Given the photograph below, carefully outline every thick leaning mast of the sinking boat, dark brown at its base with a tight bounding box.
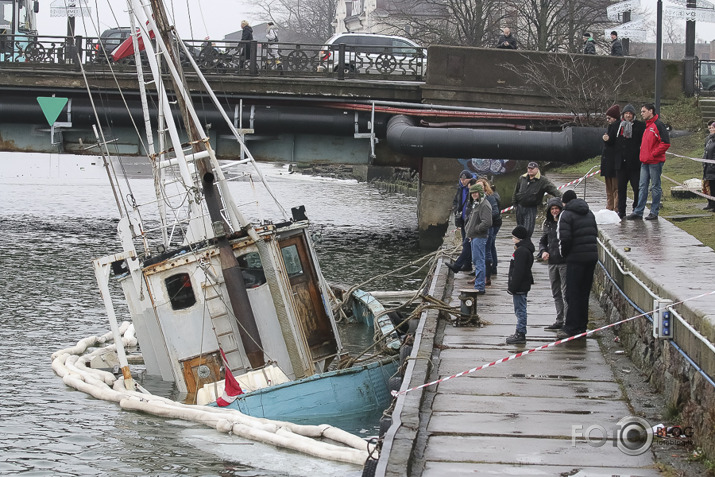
[136,0,265,368]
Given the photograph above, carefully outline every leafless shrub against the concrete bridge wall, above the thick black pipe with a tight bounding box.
[500,53,633,125]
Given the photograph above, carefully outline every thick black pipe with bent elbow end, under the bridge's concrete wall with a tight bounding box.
[387,115,603,164]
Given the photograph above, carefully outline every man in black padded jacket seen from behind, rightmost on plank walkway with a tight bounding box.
[556,190,598,339]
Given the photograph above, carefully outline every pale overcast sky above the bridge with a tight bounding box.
[38,0,715,42]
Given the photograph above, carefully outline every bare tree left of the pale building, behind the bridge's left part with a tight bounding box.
[256,0,338,43]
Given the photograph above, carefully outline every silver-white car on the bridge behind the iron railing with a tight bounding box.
[319,33,427,77]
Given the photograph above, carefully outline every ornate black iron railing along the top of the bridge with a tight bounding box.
[0,35,427,81]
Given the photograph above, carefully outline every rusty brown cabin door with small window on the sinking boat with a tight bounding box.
[279,234,337,362]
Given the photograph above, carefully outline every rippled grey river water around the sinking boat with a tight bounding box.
[0,156,423,476]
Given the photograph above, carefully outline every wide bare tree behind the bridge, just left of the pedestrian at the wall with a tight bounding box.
[378,0,504,46]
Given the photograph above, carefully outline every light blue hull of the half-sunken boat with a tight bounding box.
[224,358,398,423]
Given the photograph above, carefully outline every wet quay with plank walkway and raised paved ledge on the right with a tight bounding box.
[376,174,715,477]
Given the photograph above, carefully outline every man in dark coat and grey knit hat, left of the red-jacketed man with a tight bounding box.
[615,104,645,219]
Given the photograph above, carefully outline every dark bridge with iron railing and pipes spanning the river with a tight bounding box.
[0,37,685,245]
